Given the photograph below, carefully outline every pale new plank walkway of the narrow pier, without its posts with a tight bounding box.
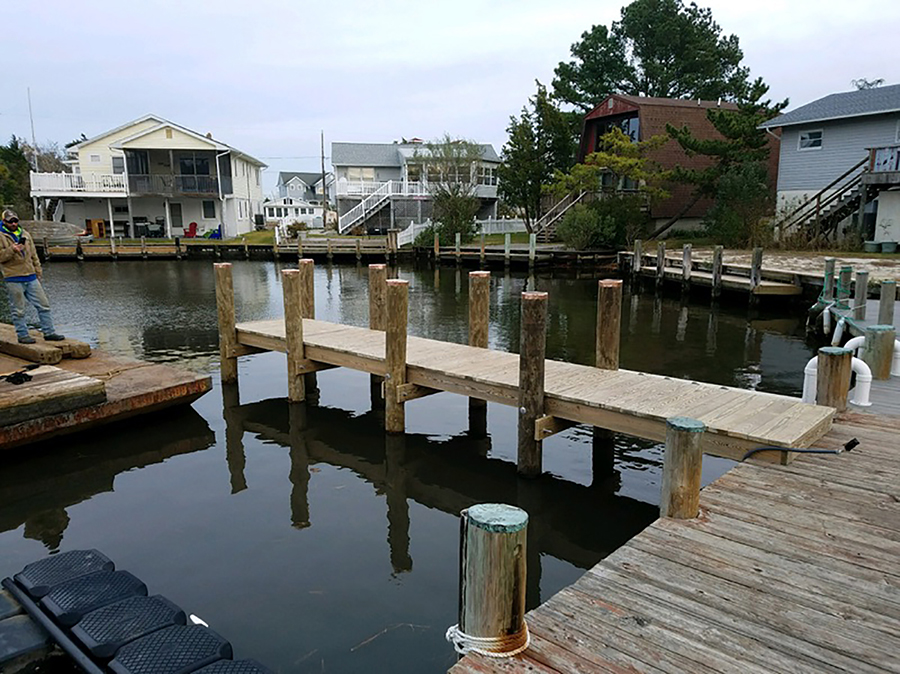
[237,319,834,459]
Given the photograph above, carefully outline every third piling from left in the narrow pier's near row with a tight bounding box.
[384,279,409,433]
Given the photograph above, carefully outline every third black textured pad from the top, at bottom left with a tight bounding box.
[72,595,187,660]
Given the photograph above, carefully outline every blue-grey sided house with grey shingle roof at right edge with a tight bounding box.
[762,85,900,241]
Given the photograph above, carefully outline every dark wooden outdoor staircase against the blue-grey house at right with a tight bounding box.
[775,156,883,239]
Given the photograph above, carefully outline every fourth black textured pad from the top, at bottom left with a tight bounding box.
[109,625,232,674]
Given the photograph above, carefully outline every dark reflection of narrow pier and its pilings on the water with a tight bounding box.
[228,399,657,588]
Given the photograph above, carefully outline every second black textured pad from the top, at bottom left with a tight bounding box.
[41,571,147,627]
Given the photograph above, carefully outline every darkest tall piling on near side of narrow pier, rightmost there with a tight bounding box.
[517,292,547,477]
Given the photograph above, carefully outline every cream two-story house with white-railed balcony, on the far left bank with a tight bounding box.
[31,115,266,238]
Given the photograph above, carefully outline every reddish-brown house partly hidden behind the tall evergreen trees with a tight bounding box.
[578,94,778,229]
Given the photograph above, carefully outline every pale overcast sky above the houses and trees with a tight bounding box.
[0,0,900,189]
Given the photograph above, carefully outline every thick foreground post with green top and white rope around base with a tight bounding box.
[458,504,533,653]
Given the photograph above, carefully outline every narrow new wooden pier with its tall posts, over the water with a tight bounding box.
[216,260,834,468]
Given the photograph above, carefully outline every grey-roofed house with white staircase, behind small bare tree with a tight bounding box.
[331,139,500,233]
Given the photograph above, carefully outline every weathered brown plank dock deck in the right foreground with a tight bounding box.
[450,413,900,674]
